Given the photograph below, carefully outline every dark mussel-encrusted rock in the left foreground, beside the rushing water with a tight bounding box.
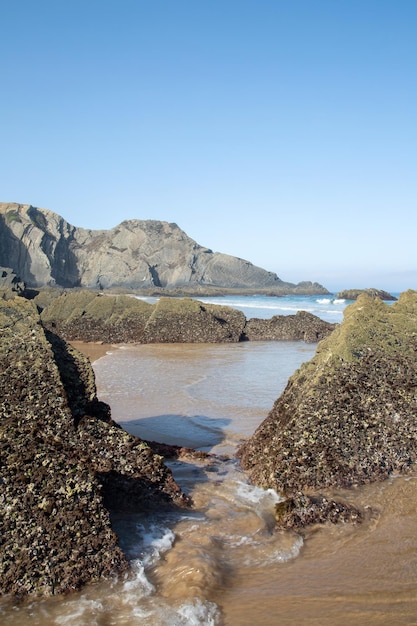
[0,298,188,594]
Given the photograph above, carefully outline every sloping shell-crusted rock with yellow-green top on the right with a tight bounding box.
[238,291,417,527]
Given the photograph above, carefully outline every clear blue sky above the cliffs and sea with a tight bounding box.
[0,0,417,291]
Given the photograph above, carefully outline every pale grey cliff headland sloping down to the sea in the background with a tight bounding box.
[0,203,327,293]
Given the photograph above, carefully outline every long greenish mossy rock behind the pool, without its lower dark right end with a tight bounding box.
[41,290,246,343]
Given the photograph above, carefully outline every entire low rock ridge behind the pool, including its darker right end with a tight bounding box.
[35,290,336,343]
